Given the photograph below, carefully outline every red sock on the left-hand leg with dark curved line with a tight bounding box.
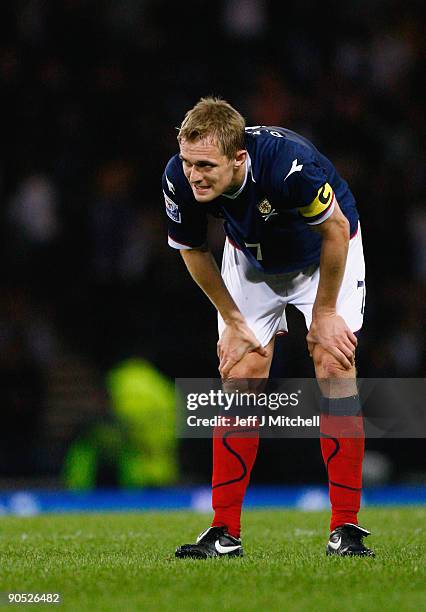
[212,427,259,538]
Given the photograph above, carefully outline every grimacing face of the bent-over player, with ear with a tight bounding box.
[180,138,247,202]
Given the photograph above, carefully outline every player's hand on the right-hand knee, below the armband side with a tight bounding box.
[306,312,358,370]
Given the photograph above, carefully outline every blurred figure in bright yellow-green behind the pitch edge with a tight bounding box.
[64,358,178,489]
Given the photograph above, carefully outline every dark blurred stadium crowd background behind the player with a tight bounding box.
[0,0,426,512]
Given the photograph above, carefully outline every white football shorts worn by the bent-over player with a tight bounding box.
[218,227,366,346]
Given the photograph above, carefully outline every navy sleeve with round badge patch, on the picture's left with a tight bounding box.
[162,158,207,250]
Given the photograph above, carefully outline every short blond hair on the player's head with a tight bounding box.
[177,97,246,159]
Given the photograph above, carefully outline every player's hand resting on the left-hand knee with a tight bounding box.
[217,323,268,379]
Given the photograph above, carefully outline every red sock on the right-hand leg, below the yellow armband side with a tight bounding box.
[320,414,364,531]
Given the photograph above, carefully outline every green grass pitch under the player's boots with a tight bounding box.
[0,507,426,612]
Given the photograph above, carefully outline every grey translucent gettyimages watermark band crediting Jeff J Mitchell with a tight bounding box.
[176,378,426,438]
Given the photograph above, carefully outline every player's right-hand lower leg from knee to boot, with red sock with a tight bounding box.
[312,344,374,556]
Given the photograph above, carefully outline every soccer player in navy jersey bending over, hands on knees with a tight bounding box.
[163,98,374,559]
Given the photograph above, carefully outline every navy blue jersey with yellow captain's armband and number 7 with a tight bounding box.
[163,126,358,274]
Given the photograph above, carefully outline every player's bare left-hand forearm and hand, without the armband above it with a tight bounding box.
[180,247,267,378]
